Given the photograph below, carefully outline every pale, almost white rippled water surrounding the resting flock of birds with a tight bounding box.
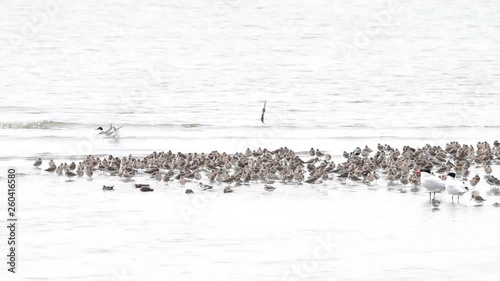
[0,0,500,281]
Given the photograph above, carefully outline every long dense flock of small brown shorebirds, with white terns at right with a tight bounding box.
[34,139,500,206]
